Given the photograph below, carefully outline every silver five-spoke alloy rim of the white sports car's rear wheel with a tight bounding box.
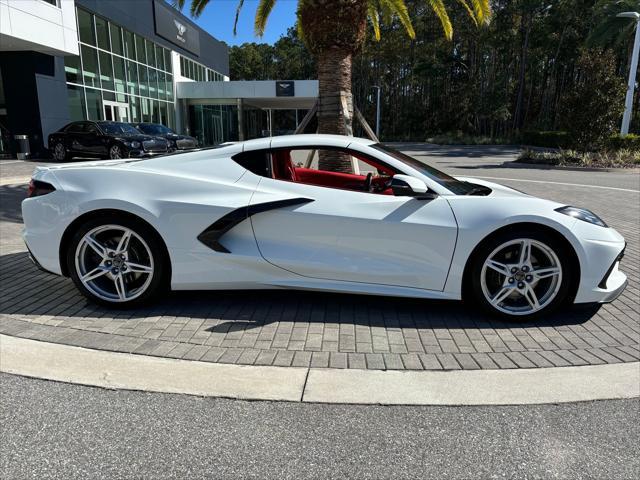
[75,225,154,302]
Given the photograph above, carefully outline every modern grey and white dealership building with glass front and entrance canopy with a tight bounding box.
[0,0,317,155]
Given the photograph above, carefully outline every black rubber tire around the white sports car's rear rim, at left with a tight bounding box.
[65,214,170,308]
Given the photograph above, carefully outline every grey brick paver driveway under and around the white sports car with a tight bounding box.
[0,151,640,369]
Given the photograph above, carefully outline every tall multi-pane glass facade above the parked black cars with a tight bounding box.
[65,8,175,128]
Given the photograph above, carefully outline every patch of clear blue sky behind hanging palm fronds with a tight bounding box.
[171,0,297,45]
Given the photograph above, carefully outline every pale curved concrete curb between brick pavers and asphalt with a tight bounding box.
[0,335,640,405]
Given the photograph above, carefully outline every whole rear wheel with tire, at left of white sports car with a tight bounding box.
[67,217,167,308]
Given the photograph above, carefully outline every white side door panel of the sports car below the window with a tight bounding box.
[251,178,457,290]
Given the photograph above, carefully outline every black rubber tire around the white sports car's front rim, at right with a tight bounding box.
[464,229,578,322]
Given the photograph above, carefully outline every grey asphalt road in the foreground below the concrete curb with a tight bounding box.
[0,375,640,479]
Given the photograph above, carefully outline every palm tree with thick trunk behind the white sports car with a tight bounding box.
[175,0,491,171]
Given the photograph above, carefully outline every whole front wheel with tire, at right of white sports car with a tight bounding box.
[470,231,575,320]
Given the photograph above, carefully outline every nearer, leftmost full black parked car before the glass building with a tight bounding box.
[49,121,169,161]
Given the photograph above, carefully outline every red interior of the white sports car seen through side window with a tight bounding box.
[272,150,394,195]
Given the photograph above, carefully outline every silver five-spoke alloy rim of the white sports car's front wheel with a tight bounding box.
[480,238,562,315]
